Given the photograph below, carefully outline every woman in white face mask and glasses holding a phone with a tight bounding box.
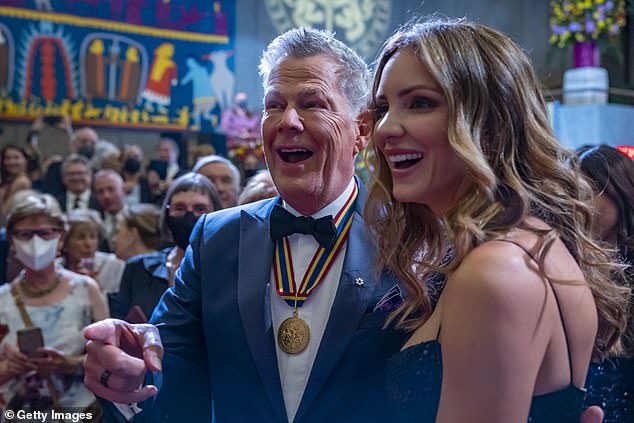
[0,192,108,413]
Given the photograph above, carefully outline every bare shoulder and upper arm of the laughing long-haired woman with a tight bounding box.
[436,243,552,423]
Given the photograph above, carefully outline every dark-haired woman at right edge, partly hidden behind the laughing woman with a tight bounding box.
[578,145,634,423]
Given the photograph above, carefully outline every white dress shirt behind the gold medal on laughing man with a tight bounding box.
[270,179,355,422]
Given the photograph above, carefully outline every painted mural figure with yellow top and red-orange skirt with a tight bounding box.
[141,43,178,113]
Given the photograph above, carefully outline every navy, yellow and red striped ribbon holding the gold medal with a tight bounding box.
[273,183,359,307]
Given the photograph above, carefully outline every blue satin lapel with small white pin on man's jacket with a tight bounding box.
[294,200,377,422]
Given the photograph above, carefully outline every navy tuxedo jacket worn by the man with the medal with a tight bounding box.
[113,190,405,423]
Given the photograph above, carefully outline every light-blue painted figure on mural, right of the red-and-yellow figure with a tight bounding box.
[181,56,216,130]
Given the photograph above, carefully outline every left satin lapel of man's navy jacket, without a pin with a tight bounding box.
[238,207,287,422]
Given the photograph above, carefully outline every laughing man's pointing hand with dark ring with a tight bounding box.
[84,319,163,404]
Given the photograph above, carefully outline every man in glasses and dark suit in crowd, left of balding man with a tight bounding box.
[56,154,101,212]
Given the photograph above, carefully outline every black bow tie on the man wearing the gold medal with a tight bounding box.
[271,204,337,250]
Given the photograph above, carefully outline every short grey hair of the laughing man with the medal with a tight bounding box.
[259,28,371,115]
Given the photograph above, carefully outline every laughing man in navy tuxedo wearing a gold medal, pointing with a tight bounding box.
[86,29,404,423]
